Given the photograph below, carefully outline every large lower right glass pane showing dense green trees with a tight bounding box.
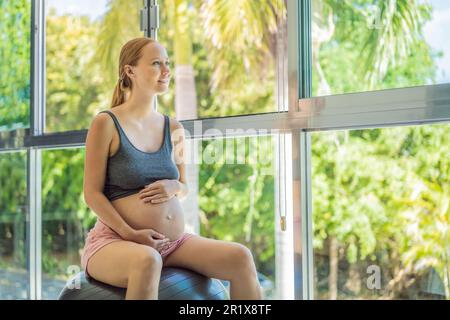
[312,124,450,299]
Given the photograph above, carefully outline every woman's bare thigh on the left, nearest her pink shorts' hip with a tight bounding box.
[87,241,159,288]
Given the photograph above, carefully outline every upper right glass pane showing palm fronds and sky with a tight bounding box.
[312,0,450,96]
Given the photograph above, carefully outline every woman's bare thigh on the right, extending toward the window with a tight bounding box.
[164,236,254,280]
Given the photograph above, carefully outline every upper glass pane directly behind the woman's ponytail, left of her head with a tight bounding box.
[46,0,143,132]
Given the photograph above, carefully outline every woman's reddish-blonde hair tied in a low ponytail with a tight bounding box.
[111,37,155,108]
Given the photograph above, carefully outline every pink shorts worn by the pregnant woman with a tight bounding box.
[81,219,194,276]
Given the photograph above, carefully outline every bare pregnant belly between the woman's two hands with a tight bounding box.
[112,193,184,240]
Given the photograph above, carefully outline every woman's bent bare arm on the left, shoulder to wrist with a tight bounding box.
[83,113,135,240]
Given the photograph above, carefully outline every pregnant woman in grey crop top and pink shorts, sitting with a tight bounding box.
[81,38,261,299]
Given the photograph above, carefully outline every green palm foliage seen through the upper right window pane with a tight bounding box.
[313,0,439,95]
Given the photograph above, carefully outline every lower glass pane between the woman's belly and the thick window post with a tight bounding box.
[191,136,284,299]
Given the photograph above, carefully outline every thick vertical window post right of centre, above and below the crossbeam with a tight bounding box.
[287,0,312,299]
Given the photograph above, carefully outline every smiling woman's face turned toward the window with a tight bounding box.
[127,42,171,94]
